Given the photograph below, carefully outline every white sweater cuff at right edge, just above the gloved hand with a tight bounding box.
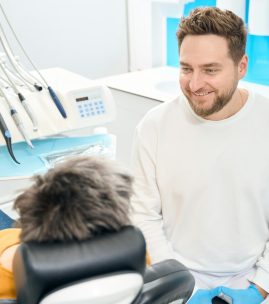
[252,242,269,293]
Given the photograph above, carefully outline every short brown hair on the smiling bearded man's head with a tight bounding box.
[177,7,247,63]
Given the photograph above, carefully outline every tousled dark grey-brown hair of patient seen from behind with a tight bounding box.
[14,157,133,242]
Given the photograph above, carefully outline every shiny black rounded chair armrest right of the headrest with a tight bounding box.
[135,260,194,304]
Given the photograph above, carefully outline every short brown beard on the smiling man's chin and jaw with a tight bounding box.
[184,83,237,118]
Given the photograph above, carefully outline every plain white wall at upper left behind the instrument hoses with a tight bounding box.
[0,0,128,79]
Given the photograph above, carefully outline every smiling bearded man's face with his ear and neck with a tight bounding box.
[180,35,247,120]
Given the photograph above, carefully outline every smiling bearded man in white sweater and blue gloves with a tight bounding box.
[132,8,269,304]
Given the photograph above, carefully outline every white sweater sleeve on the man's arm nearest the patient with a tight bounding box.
[132,121,174,263]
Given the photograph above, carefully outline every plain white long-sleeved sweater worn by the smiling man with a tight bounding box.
[132,93,269,292]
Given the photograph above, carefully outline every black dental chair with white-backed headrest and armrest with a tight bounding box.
[9,226,194,304]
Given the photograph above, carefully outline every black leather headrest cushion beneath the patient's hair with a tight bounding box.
[13,226,146,304]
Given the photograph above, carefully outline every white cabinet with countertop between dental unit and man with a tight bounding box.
[99,67,179,167]
